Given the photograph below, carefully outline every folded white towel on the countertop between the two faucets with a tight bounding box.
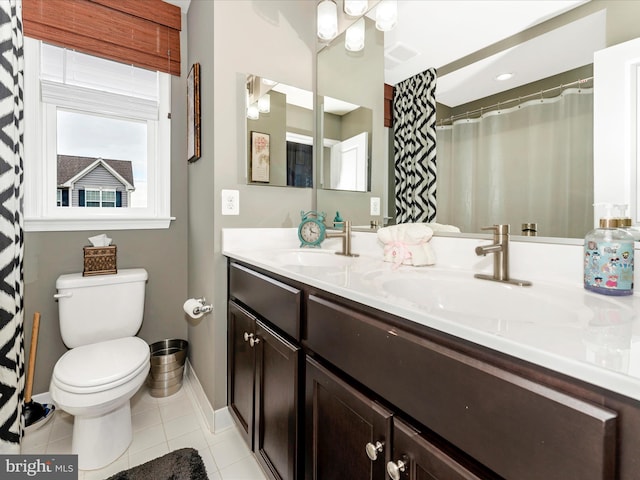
[378,223,436,266]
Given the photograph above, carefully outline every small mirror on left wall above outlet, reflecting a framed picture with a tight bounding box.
[245,74,314,188]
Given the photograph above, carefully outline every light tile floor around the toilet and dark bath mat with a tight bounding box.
[22,382,266,480]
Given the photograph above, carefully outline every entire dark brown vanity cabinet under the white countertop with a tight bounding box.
[228,262,640,480]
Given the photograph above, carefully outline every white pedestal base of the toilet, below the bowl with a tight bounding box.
[71,400,133,470]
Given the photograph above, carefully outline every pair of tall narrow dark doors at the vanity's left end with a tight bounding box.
[227,262,301,480]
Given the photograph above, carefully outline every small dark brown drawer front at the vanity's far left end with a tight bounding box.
[229,263,302,340]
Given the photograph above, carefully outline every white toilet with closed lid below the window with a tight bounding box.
[49,268,150,470]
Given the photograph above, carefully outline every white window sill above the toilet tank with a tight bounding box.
[24,217,175,232]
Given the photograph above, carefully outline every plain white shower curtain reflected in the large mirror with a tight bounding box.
[437,88,593,238]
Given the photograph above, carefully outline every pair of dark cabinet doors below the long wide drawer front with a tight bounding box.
[305,357,484,480]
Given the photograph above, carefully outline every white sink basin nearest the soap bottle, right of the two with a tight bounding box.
[378,270,633,330]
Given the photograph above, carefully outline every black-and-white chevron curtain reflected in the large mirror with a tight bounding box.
[393,68,436,223]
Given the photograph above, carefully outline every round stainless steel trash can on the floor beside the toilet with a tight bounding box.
[147,339,189,397]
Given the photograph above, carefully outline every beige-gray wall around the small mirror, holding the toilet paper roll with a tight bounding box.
[187,0,316,409]
